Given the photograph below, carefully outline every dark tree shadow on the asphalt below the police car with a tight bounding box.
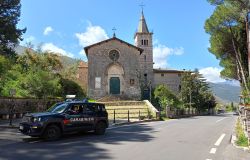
[0,124,154,160]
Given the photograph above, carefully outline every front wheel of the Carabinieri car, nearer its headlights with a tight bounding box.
[43,125,62,141]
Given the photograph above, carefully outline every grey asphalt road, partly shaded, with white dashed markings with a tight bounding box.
[0,114,250,160]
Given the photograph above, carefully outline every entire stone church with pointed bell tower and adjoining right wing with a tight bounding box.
[79,12,181,100]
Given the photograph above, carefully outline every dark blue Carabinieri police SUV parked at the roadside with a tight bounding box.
[19,101,109,140]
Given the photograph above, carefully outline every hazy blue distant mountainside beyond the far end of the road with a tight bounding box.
[209,83,241,103]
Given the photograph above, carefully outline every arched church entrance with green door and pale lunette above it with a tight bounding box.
[107,64,124,95]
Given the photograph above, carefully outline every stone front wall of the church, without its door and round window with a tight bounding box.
[88,39,141,99]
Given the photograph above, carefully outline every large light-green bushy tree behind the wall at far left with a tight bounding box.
[0,49,62,98]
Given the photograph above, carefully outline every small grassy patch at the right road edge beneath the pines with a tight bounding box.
[236,119,249,147]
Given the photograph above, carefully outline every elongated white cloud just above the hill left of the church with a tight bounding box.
[41,43,74,58]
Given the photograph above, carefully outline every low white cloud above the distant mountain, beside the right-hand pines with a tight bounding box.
[199,67,226,83]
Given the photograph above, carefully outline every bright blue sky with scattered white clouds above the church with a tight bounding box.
[18,0,236,83]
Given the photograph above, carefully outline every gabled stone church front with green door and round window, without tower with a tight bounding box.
[85,36,143,99]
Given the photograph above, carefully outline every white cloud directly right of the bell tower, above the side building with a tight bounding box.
[153,42,184,68]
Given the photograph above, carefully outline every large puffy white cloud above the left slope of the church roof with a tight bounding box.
[75,22,108,55]
